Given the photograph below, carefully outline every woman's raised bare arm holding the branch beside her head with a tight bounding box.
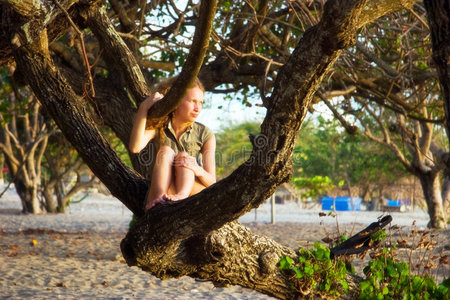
[128,93,163,153]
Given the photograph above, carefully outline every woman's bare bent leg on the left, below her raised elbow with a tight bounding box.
[145,146,175,210]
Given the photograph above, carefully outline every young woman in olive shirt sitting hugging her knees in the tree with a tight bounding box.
[129,78,216,210]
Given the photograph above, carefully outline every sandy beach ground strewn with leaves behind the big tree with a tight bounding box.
[0,188,450,299]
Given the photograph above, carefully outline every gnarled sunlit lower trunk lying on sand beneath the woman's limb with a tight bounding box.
[121,216,358,299]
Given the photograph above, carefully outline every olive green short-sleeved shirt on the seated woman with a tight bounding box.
[147,122,213,179]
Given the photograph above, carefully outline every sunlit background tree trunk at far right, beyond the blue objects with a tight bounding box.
[417,171,447,228]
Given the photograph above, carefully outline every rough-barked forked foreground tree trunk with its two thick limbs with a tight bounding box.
[0,0,414,298]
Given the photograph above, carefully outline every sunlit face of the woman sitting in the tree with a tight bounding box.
[173,87,204,122]
